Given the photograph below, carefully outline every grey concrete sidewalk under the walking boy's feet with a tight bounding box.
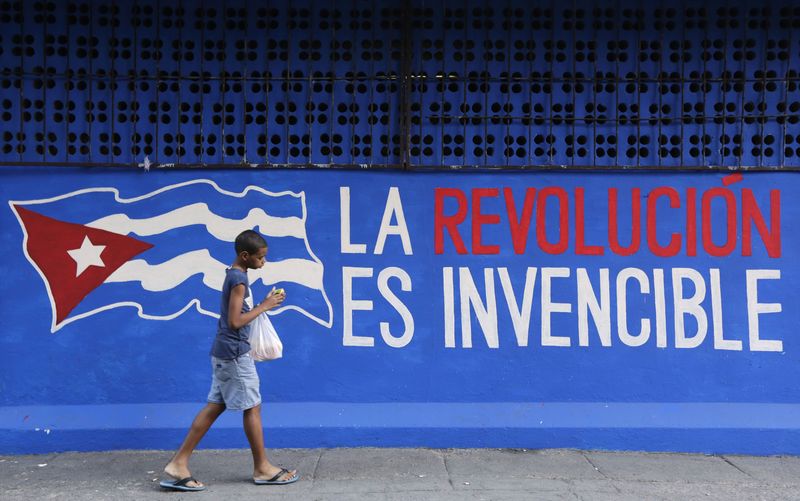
[0,448,800,501]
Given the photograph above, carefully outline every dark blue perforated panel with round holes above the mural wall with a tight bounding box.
[0,0,800,169]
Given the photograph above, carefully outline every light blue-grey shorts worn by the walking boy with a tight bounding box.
[208,353,261,411]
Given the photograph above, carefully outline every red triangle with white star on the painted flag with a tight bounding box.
[14,205,153,325]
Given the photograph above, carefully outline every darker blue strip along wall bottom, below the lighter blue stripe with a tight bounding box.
[0,428,800,455]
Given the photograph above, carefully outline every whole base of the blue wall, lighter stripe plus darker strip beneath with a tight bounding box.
[0,402,800,455]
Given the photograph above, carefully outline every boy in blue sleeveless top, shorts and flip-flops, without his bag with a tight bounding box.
[160,230,300,491]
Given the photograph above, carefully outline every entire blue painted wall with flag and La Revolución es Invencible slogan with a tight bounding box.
[0,168,800,454]
